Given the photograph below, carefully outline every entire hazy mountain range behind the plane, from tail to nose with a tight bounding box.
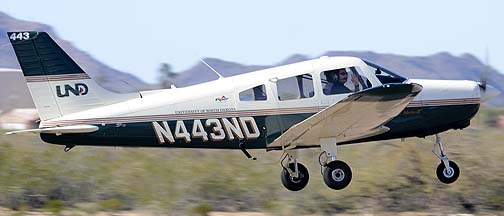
[0,12,504,111]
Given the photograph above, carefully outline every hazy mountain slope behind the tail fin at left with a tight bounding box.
[0,12,150,93]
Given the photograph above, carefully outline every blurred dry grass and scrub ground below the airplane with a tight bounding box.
[0,106,504,215]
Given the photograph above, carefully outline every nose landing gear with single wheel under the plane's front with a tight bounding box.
[432,134,460,184]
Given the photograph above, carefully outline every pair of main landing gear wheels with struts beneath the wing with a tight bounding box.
[280,138,352,191]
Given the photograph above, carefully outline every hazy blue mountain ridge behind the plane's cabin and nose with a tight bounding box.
[175,51,504,106]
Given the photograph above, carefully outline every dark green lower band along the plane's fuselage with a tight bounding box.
[41,104,479,149]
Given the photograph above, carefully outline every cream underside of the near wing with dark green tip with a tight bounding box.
[268,83,422,148]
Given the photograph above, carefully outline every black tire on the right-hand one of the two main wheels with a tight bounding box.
[323,160,352,190]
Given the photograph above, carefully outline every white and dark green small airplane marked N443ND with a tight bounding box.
[7,31,499,191]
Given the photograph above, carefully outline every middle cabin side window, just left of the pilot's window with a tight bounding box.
[277,74,314,101]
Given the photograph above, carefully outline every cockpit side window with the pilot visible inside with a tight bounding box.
[320,67,371,95]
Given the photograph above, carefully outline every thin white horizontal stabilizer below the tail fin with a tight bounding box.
[5,125,99,135]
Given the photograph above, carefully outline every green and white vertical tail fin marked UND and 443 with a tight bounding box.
[7,32,131,121]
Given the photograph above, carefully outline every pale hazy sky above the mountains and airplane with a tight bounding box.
[0,0,504,82]
